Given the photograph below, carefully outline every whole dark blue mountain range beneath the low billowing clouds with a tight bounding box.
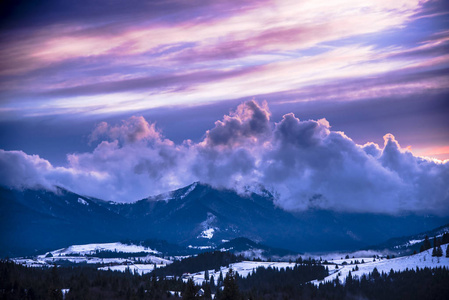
[0,183,449,256]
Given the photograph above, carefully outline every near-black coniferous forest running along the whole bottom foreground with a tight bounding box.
[0,261,449,300]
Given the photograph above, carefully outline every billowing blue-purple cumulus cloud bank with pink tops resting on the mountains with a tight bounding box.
[0,101,449,215]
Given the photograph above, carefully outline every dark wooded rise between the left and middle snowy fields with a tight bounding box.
[155,251,244,276]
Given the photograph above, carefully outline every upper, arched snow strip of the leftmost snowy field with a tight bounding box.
[40,242,159,257]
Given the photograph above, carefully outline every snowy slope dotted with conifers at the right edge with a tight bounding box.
[312,244,449,285]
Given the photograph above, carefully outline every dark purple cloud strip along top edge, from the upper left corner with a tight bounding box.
[0,0,266,27]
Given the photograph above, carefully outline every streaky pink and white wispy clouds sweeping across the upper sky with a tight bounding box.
[0,0,449,116]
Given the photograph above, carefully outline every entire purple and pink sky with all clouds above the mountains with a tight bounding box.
[0,0,449,214]
